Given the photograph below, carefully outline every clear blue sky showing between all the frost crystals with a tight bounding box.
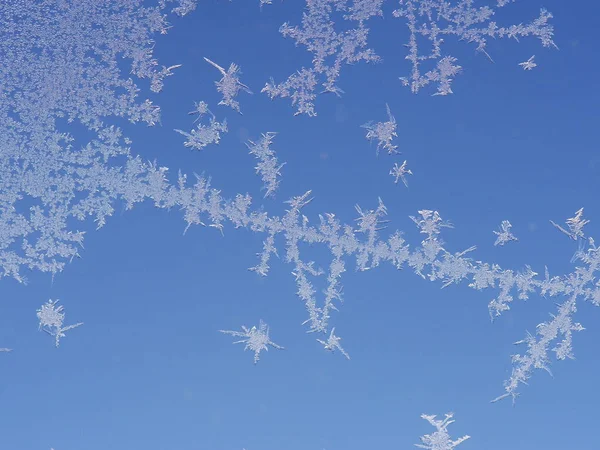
[0,0,600,450]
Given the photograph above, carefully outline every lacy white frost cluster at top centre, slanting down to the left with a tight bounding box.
[262,0,383,116]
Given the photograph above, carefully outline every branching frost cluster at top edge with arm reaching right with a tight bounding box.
[393,0,556,95]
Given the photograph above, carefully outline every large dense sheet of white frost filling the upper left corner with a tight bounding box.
[0,0,195,281]
